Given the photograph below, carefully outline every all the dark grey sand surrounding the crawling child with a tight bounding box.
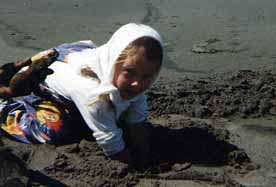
[0,0,276,187]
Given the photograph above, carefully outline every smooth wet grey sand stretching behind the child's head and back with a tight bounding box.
[0,0,276,76]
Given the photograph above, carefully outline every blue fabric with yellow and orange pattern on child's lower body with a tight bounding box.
[1,95,65,143]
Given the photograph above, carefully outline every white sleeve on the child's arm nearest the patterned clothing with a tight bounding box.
[70,92,125,156]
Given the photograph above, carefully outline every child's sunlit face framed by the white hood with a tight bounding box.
[113,47,160,100]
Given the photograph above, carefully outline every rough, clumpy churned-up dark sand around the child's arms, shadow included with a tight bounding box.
[0,71,276,187]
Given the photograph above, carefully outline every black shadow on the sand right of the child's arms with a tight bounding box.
[149,124,250,166]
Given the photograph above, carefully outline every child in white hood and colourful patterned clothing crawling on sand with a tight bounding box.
[2,23,163,166]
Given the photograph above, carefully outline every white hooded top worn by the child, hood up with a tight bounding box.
[46,23,163,155]
